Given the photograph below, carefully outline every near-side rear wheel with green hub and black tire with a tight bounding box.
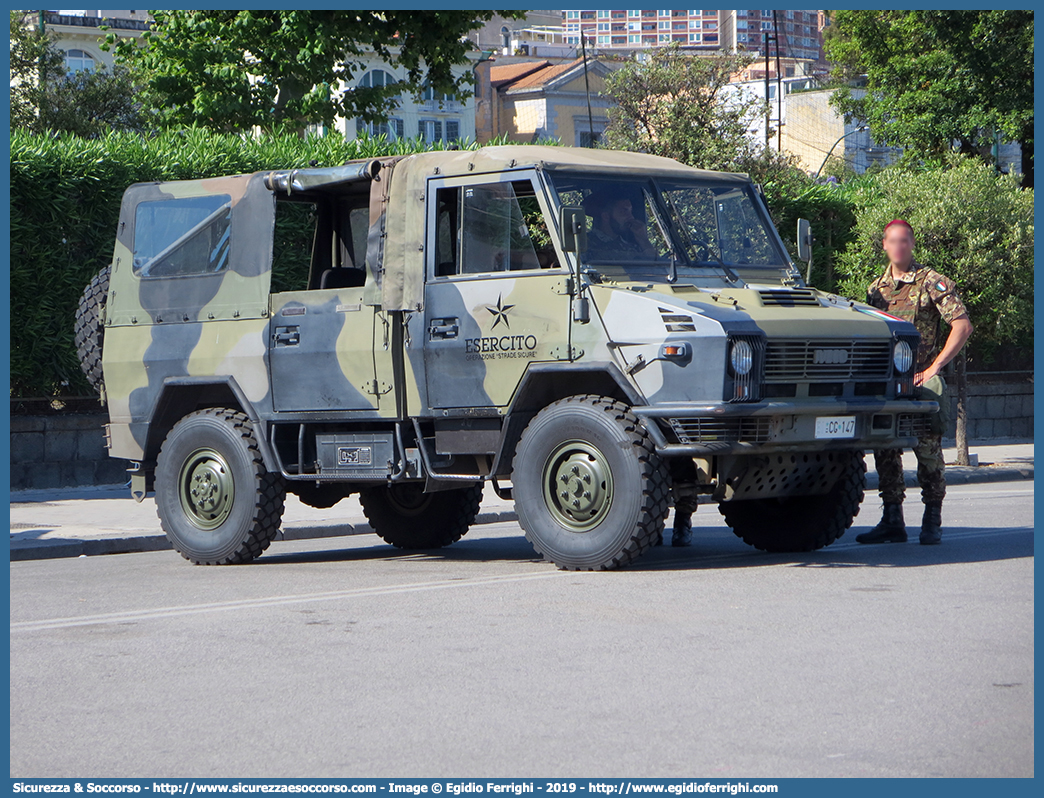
[156,407,286,565]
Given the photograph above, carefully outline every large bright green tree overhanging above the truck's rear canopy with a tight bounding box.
[105,10,523,132]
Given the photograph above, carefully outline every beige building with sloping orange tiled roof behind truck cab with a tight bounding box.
[476,58,614,146]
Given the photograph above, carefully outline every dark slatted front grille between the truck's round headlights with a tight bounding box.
[765,339,892,382]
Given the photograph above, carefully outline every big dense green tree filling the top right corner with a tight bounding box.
[824,10,1034,187]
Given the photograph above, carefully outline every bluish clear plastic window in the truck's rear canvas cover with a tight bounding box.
[134,194,232,277]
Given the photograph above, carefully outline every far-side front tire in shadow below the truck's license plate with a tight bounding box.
[718,451,867,553]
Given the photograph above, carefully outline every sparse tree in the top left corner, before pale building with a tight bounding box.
[10,11,65,131]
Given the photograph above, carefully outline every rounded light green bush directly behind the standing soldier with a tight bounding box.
[838,154,1034,361]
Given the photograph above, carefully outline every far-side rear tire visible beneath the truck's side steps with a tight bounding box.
[359,483,482,548]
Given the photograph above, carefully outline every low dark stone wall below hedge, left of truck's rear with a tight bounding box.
[10,414,128,491]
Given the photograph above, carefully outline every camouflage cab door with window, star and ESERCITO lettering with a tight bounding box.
[424,170,570,408]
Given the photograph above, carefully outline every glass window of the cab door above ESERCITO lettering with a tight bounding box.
[435,181,557,277]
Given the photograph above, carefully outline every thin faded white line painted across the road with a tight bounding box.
[10,569,576,633]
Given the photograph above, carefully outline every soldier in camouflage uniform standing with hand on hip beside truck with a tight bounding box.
[856,219,972,544]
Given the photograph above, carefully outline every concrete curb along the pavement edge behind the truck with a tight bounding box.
[10,464,1034,562]
